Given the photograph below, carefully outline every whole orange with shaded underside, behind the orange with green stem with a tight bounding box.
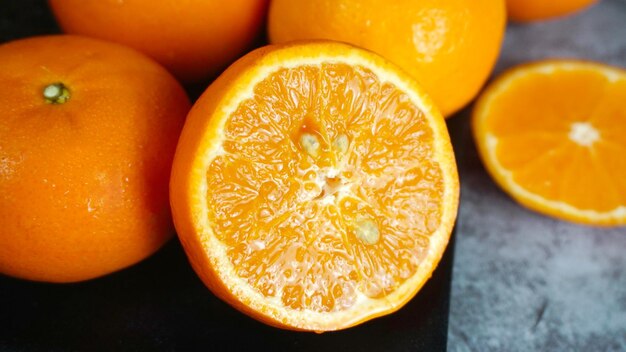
[49,0,268,83]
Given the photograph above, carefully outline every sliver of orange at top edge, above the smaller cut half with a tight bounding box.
[506,0,598,22]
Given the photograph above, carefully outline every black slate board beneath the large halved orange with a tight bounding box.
[0,0,453,351]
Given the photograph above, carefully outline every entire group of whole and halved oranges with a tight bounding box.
[0,0,626,332]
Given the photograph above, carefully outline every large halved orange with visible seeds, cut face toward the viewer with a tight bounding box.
[170,42,459,331]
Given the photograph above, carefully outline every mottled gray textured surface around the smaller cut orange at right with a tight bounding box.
[448,0,626,352]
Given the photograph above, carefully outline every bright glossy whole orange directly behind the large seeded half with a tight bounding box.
[268,0,506,116]
